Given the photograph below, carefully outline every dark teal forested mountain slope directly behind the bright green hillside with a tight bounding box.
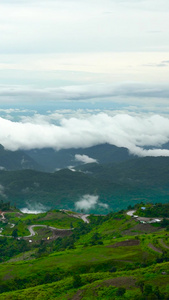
[0,157,169,214]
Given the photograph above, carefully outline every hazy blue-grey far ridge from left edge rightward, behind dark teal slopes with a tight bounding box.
[0,143,169,172]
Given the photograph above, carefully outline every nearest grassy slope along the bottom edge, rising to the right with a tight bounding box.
[0,263,169,300]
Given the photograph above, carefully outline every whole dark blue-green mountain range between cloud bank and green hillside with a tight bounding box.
[0,144,169,214]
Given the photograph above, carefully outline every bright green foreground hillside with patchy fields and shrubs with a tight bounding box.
[0,204,169,300]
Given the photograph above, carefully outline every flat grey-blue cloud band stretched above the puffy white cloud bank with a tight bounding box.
[0,82,169,105]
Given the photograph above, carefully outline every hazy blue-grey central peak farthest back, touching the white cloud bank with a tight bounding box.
[25,144,134,172]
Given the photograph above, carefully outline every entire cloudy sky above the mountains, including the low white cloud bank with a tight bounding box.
[0,0,169,156]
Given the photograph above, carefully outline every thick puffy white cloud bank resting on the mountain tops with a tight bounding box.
[0,113,169,157]
